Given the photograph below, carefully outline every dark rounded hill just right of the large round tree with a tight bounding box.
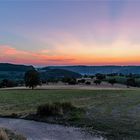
[40,68,81,79]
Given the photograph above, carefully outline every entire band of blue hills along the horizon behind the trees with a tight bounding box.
[0,63,140,80]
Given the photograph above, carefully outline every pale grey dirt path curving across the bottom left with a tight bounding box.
[0,118,103,140]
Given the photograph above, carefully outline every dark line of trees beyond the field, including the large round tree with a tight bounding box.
[0,69,140,89]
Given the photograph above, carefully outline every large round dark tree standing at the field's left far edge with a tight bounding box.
[24,70,40,89]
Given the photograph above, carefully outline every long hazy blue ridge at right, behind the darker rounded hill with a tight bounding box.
[43,66,140,75]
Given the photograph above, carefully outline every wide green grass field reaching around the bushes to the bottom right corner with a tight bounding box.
[0,90,140,139]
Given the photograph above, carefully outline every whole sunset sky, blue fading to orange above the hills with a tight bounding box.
[0,0,140,66]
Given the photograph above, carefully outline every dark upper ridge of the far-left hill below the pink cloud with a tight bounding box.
[0,63,34,72]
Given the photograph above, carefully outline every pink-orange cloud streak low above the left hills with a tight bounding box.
[0,45,74,65]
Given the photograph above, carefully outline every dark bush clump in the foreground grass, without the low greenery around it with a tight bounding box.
[37,102,75,116]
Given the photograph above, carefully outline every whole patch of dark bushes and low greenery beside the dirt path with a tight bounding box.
[35,102,85,125]
